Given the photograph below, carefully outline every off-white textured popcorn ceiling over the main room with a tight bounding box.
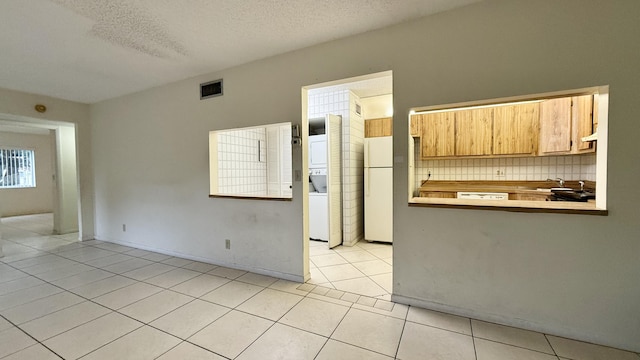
[0,0,479,103]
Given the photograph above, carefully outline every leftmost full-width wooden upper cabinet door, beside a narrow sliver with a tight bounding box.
[420,111,455,158]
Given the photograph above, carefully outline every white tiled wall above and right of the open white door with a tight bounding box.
[308,89,364,243]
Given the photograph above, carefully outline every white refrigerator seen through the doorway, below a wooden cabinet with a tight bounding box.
[364,136,393,242]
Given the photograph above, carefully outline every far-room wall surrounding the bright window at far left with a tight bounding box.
[0,132,53,216]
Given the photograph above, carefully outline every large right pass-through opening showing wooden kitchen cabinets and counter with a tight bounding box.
[408,86,609,215]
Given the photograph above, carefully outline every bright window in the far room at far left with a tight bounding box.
[0,148,36,189]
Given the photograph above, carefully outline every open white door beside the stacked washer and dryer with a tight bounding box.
[325,115,342,248]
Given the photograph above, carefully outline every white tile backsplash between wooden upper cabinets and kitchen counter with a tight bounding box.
[414,139,596,187]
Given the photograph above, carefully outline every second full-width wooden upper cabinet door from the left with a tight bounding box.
[455,108,493,156]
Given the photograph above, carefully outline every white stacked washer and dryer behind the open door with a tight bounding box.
[309,135,329,241]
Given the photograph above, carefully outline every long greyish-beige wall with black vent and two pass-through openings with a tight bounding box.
[89,0,640,351]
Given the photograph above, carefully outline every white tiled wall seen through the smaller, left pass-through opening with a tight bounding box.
[218,128,267,196]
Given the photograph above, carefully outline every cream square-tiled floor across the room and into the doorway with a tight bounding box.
[0,215,640,360]
